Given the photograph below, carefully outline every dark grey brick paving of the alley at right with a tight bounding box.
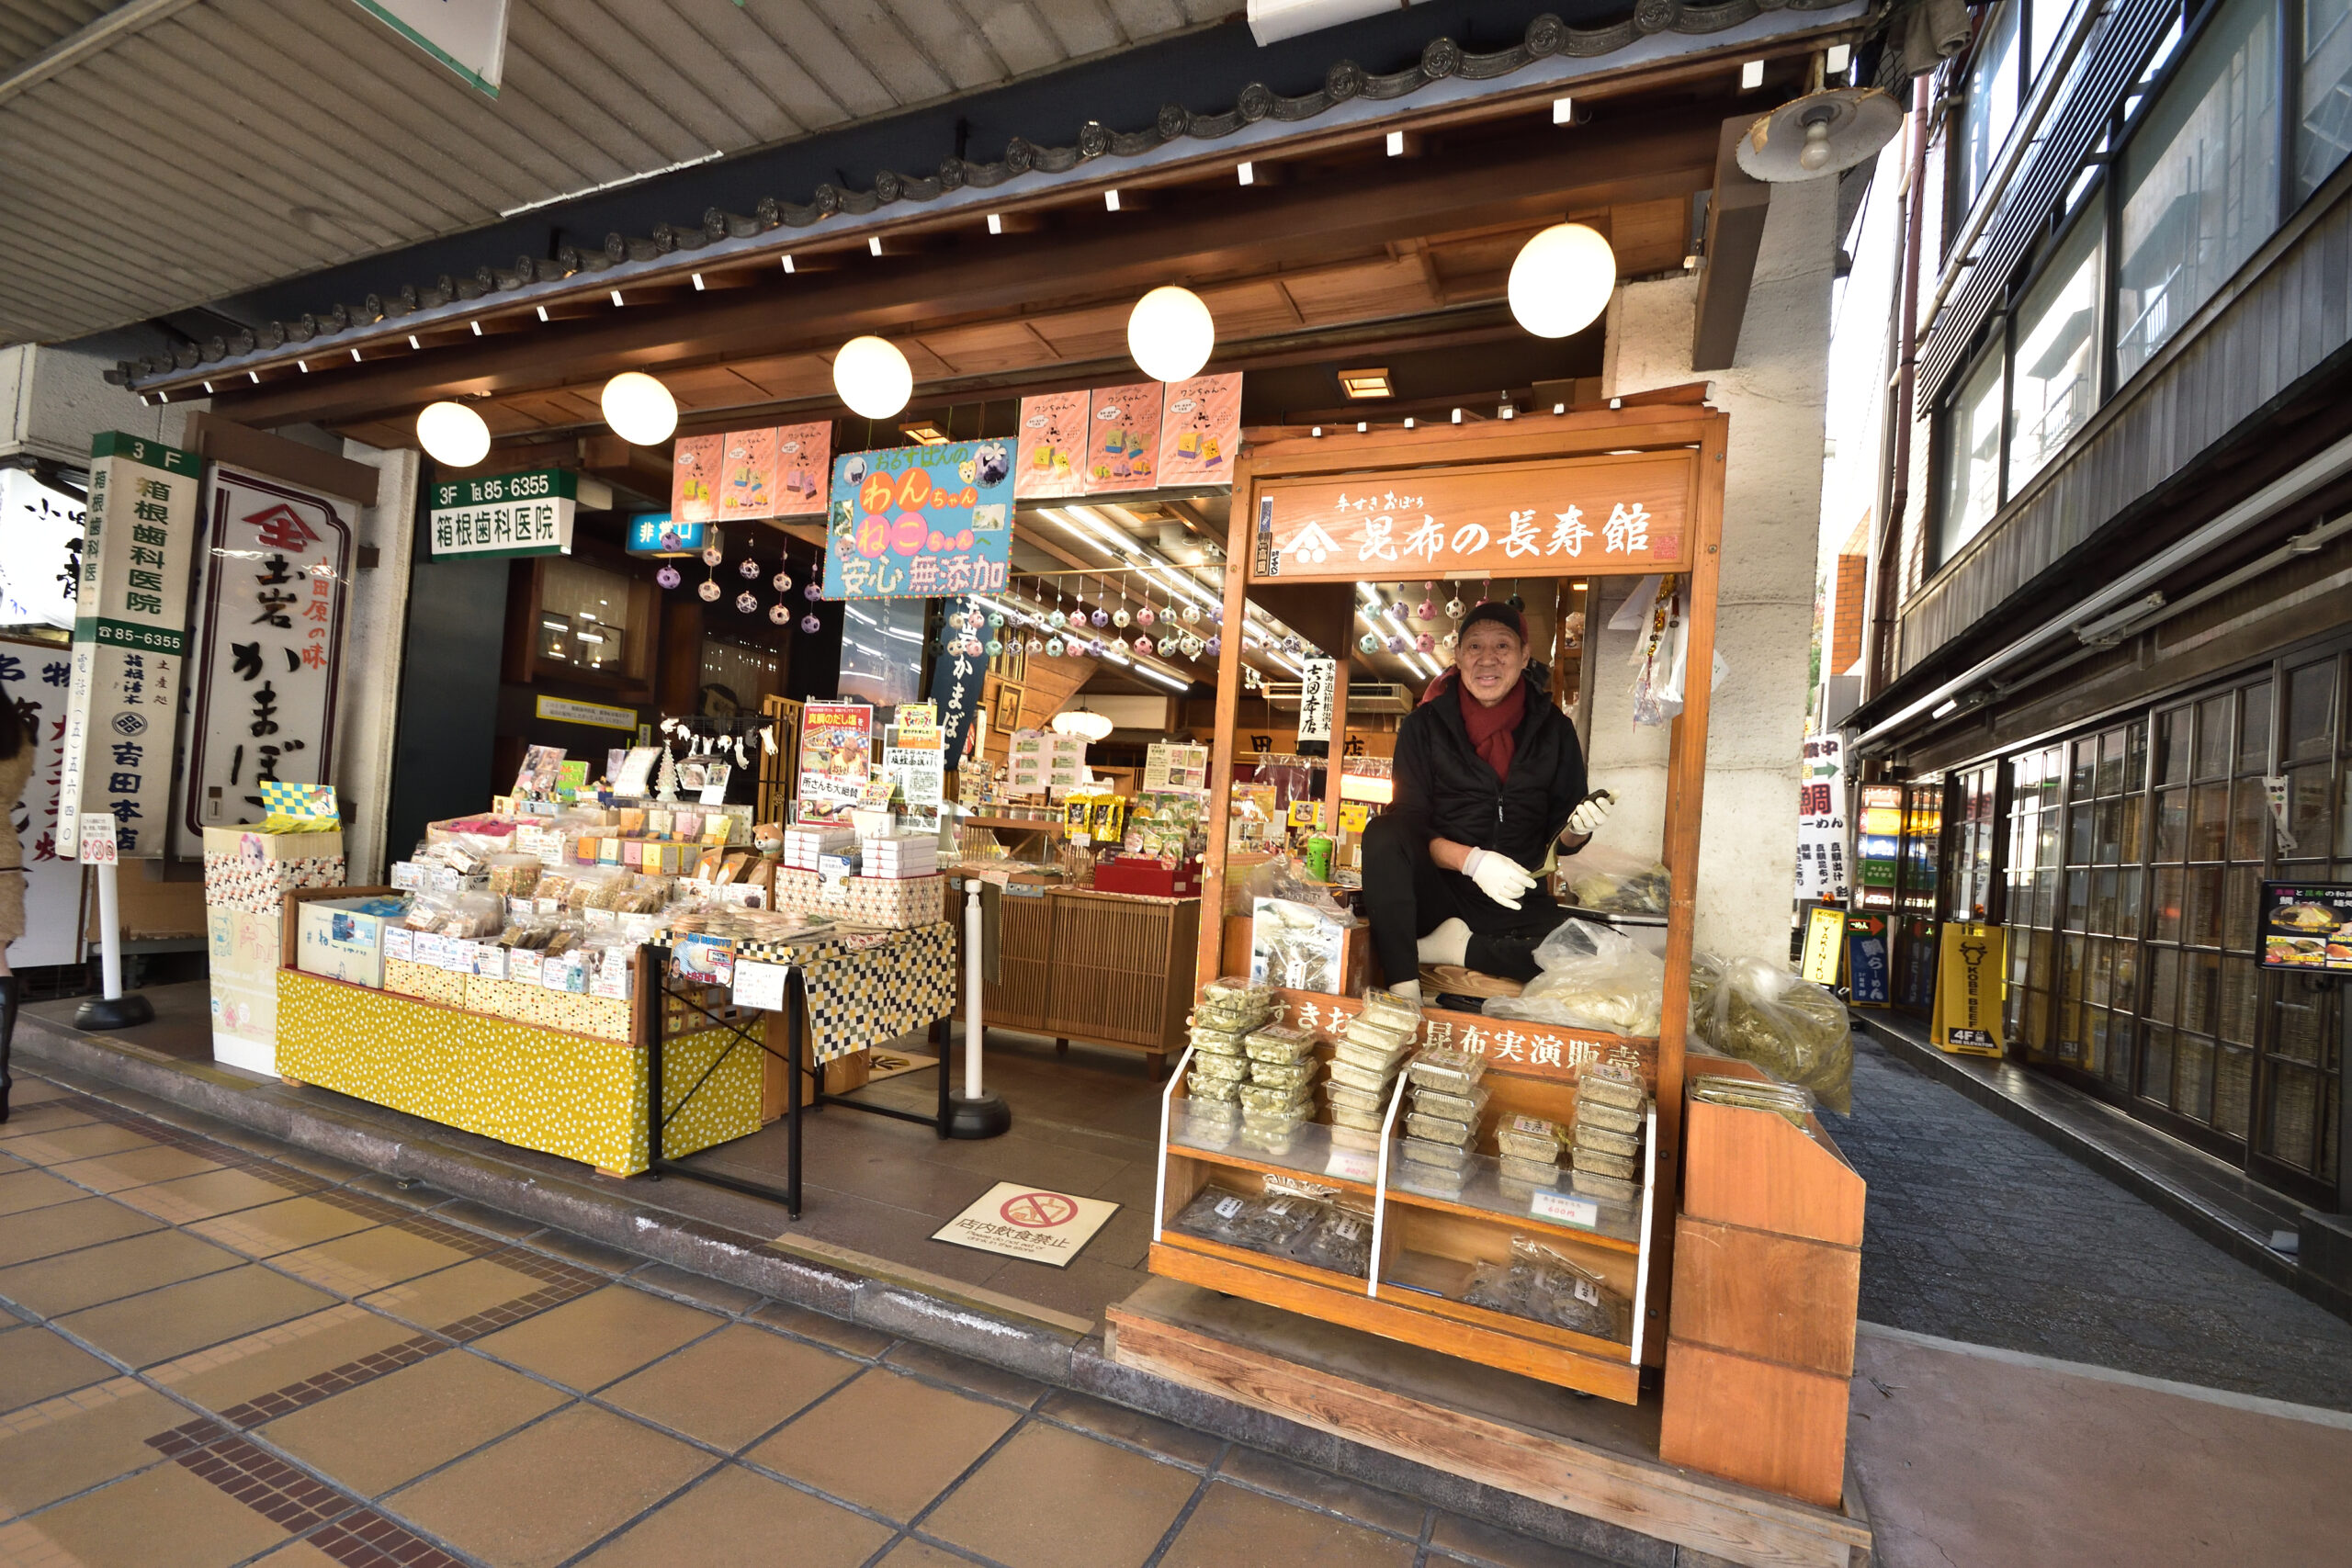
[1823,1032,2352,1411]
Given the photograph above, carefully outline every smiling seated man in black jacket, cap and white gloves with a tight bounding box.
[1364,602,1613,997]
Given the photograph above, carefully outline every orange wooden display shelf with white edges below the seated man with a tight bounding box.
[1150,1043,1656,1404]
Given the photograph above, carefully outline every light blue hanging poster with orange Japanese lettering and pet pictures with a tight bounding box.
[826,440,1013,600]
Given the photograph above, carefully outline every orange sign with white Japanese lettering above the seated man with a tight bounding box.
[1249,451,1693,583]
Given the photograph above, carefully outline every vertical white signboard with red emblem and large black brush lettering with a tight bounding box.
[181,463,350,840]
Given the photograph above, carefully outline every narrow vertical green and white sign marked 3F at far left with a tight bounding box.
[56,430,202,861]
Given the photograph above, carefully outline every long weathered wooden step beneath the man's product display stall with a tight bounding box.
[1108,1279,1870,1568]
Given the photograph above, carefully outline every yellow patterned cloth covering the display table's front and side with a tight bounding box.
[277,971,760,1176]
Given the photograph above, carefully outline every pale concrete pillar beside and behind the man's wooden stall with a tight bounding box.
[1585,179,1837,959]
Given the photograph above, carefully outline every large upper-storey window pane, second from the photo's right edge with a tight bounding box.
[2114,0,2279,381]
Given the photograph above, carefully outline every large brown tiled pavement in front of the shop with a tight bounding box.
[0,1077,1583,1568]
